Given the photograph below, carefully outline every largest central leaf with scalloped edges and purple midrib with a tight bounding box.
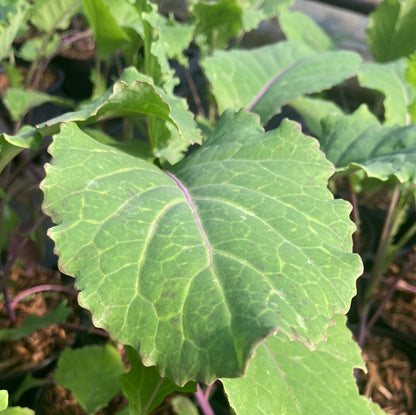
[42,110,361,385]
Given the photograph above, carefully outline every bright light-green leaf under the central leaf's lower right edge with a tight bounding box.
[222,315,384,415]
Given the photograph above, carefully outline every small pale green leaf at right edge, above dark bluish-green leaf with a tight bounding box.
[358,59,415,125]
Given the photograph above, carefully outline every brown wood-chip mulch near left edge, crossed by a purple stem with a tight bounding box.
[0,269,77,374]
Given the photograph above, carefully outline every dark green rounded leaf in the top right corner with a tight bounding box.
[367,0,416,62]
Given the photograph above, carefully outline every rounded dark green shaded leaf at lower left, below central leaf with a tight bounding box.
[55,343,126,414]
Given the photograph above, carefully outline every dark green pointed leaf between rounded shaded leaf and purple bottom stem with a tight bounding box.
[120,346,196,415]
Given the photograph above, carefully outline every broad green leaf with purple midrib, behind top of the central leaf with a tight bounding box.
[203,42,361,123]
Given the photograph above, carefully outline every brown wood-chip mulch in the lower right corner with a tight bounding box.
[359,248,416,415]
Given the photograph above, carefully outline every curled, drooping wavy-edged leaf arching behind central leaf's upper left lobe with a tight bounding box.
[0,68,202,167]
